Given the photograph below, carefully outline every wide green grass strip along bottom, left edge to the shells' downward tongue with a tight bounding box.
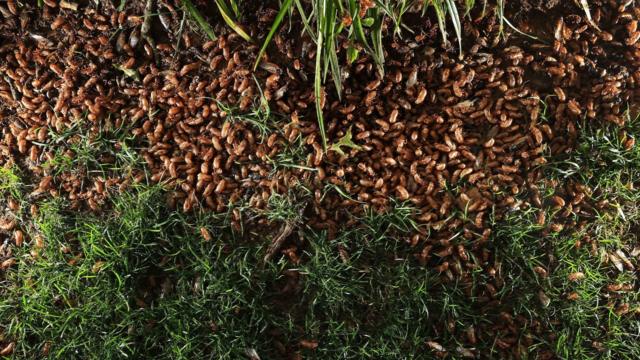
[0,186,472,359]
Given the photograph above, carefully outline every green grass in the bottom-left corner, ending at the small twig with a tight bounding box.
[0,187,282,359]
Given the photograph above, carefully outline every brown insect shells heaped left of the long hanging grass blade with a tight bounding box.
[0,2,298,224]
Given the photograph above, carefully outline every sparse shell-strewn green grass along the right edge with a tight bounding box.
[494,111,640,359]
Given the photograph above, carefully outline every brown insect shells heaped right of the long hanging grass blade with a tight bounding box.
[258,0,640,270]
